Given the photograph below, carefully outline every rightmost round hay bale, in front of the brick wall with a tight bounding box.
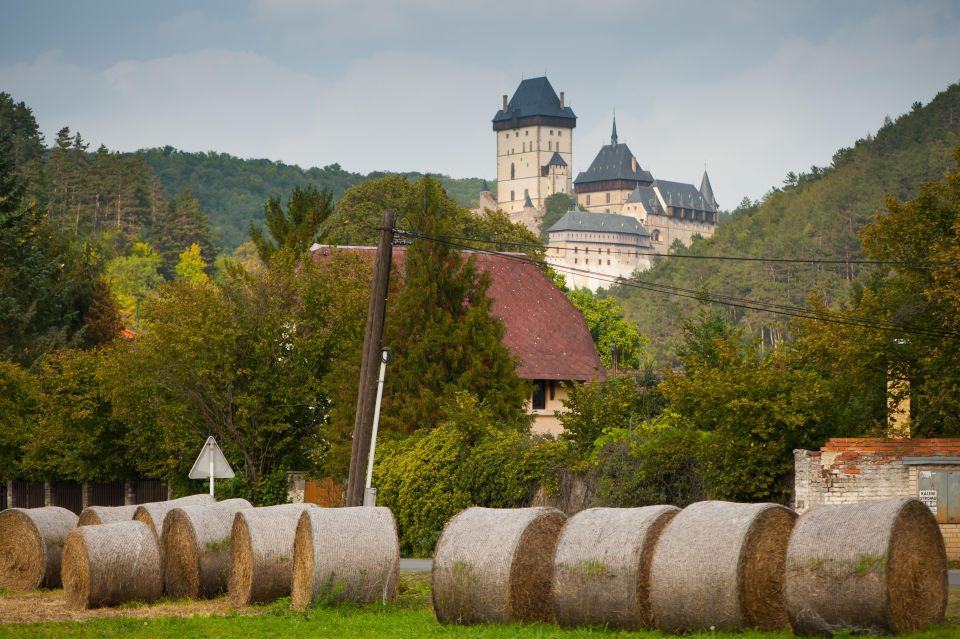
[786,498,949,635]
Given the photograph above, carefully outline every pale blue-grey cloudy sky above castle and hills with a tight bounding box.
[0,0,960,209]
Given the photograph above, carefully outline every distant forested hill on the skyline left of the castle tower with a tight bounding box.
[137,146,483,251]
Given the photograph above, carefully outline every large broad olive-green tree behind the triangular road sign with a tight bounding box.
[107,251,364,494]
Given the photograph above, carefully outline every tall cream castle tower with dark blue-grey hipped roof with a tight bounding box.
[493,77,577,219]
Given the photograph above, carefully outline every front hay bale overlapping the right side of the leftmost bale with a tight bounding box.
[61,520,163,608]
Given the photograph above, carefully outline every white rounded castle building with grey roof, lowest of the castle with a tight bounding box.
[546,211,653,292]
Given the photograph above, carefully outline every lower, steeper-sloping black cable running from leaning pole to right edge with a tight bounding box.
[398,231,960,339]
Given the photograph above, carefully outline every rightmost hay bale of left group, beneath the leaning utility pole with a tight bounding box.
[291,507,400,610]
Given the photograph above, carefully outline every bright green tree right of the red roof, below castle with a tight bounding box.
[567,288,652,370]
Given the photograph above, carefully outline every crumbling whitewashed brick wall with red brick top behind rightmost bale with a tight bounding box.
[794,438,960,559]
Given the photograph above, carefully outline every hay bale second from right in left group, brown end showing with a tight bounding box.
[229,504,316,607]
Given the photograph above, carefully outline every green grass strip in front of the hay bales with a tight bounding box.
[0,575,960,639]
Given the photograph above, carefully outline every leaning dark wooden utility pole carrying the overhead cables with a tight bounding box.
[346,209,393,506]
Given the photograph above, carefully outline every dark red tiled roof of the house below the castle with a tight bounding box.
[314,246,606,381]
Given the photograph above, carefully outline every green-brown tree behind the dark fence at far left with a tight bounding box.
[21,350,134,481]
